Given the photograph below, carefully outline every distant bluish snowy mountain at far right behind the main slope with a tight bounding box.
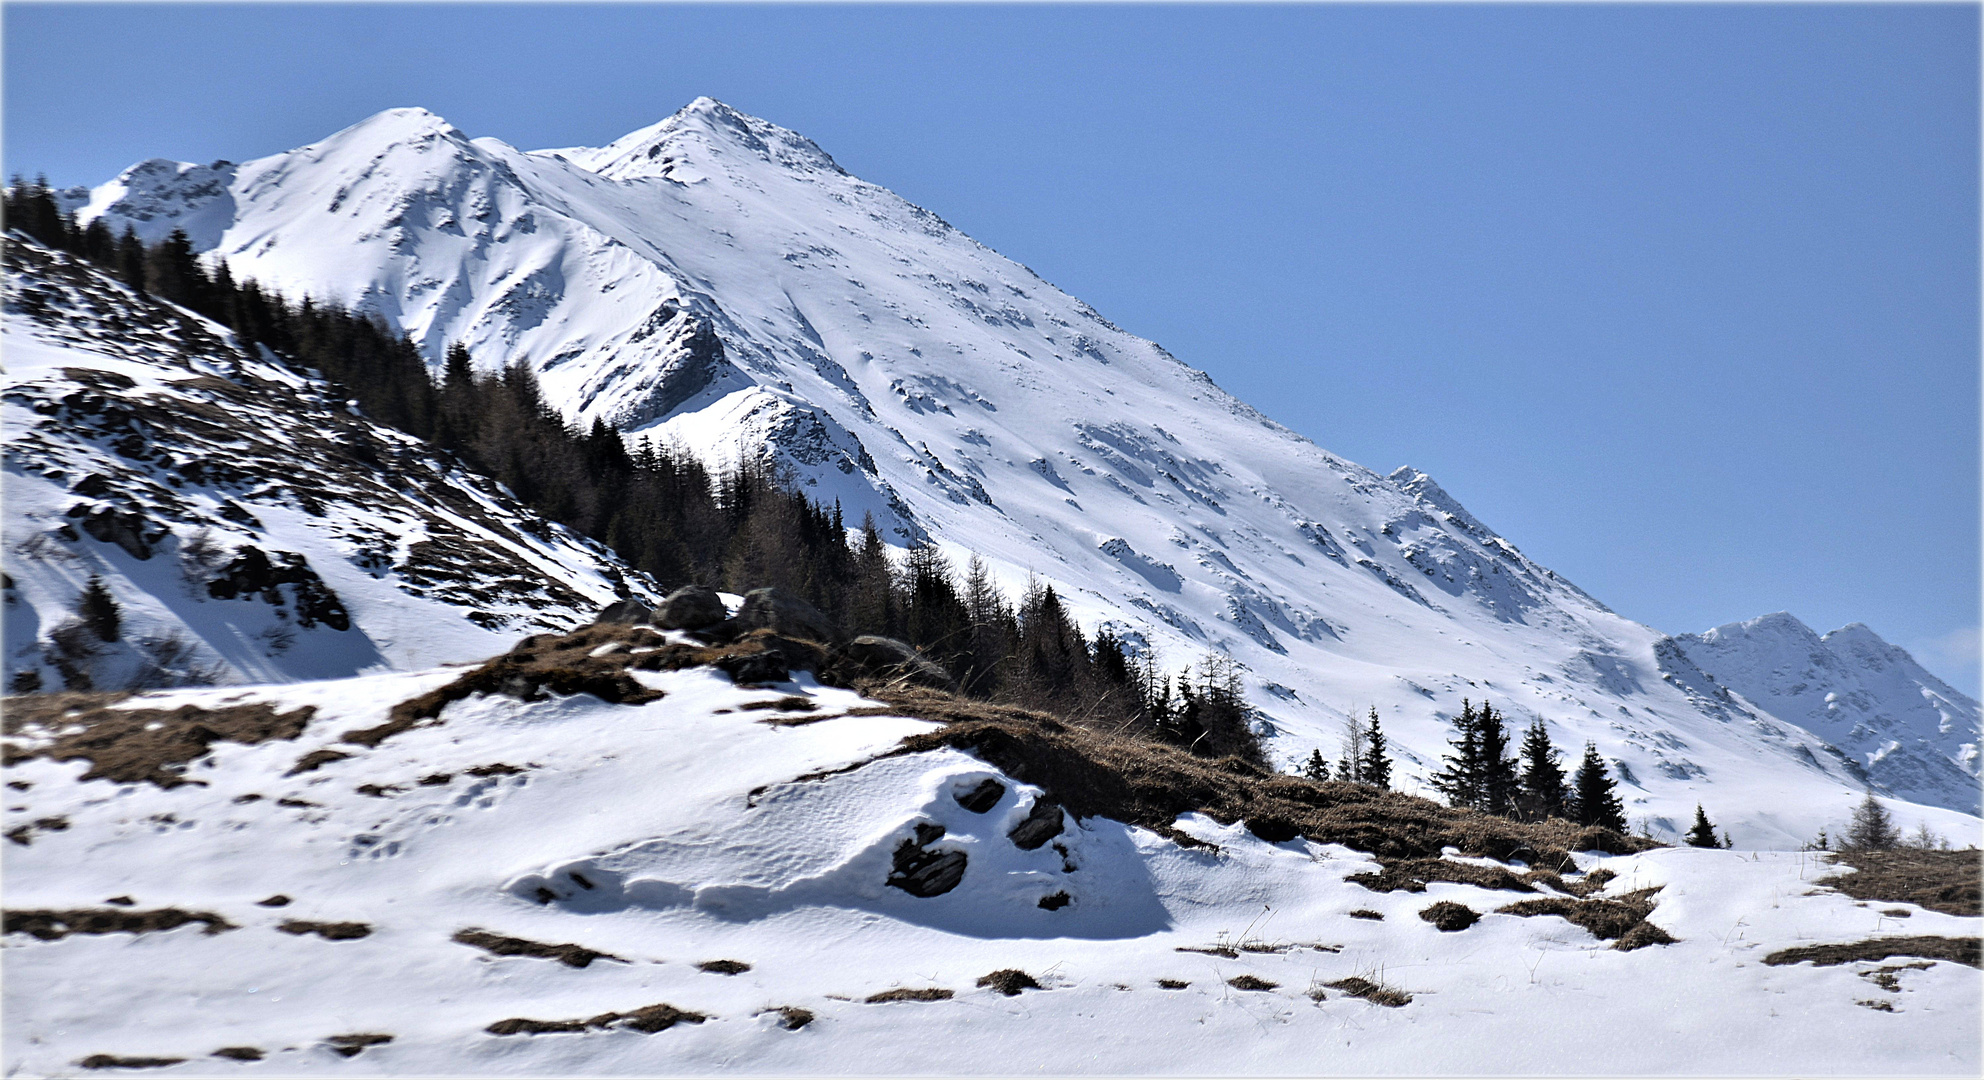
[1674,611,1984,814]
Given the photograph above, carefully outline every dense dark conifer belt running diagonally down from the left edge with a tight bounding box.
[4,177,1266,766]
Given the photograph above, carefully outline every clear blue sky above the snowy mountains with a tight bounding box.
[4,4,1980,695]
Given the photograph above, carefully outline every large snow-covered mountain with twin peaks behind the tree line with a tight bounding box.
[63,99,1976,848]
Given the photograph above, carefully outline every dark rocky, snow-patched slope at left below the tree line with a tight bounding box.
[0,238,653,693]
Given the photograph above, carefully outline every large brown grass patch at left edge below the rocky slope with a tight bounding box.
[0,693,315,788]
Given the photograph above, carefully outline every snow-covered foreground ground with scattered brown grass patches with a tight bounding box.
[4,669,1984,1076]
